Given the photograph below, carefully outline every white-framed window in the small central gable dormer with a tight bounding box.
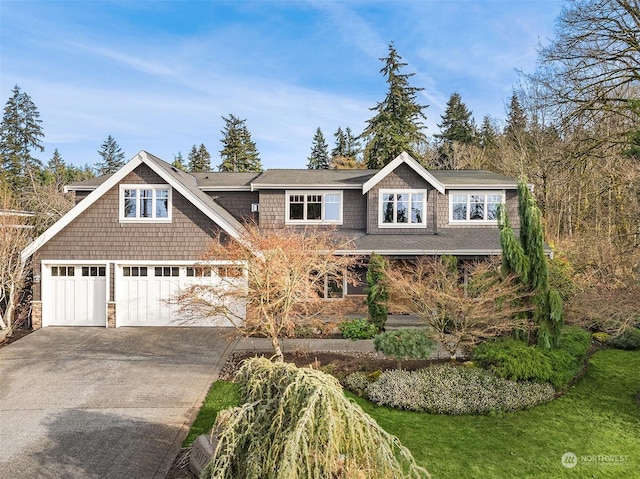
[378,190,427,228]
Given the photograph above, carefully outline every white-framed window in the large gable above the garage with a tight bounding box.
[120,185,171,222]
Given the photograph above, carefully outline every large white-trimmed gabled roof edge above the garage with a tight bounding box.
[22,151,244,261]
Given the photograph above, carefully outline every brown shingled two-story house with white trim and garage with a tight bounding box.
[23,151,518,328]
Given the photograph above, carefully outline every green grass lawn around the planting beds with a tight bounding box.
[185,350,640,479]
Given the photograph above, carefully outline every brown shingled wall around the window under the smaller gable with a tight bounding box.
[367,164,436,235]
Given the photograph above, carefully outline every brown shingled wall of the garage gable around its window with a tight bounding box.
[33,165,228,300]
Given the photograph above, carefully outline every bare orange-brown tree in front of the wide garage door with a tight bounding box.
[177,226,358,361]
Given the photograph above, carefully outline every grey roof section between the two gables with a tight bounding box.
[251,169,378,191]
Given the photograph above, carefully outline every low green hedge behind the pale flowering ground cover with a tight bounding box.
[473,326,591,389]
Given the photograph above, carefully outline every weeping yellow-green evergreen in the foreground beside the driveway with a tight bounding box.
[200,358,430,479]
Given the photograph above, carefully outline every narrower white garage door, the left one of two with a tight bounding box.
[42,264,107,326]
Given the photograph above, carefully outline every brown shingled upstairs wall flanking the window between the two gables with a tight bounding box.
[259,189,367,230]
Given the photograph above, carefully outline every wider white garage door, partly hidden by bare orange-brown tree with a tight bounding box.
[115,265,244,326]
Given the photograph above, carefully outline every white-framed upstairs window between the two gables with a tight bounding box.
[285,191,342,224]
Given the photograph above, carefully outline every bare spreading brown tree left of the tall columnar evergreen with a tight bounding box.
[387,257,533,357]
